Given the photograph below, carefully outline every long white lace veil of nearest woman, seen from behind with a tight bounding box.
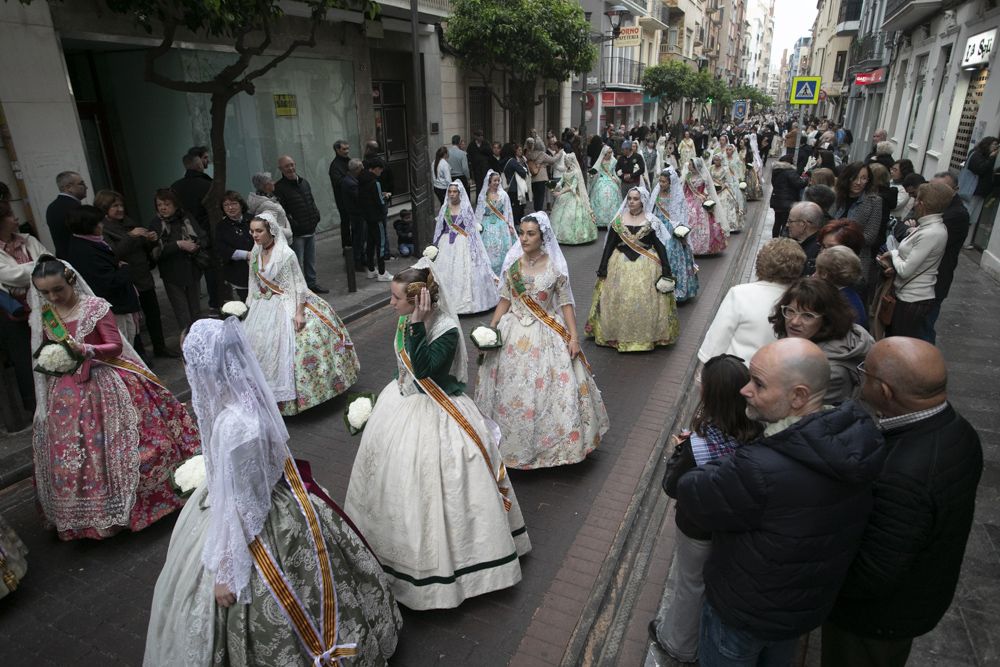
[184,316,291,603]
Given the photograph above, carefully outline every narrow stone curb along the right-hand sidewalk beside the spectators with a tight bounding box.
[559,180,768,667]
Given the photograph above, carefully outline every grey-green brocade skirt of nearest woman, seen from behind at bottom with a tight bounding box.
[143,481,402,667]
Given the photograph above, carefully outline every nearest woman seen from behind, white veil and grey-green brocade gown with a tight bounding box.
[143,317,402,667]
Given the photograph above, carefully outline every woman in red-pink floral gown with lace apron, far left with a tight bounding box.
[29,255,200,540]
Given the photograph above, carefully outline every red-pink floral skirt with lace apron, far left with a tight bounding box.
[34,363,201,540]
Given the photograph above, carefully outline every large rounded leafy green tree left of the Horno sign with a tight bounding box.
[445,0,597,136]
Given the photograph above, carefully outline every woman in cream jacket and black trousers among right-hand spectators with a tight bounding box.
[878,183,955,342]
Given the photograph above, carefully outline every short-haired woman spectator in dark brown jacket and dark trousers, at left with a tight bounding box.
[94,190,180,359]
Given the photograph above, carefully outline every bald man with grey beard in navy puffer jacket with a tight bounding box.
[677,338,884,665]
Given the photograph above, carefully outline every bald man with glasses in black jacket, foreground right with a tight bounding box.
[823,336,983,667]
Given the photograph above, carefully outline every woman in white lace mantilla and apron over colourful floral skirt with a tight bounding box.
[244,211,360,415]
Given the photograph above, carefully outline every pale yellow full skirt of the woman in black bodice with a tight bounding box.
[585,251,680,352]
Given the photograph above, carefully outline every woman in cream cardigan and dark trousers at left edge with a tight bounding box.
[0,201,52,412]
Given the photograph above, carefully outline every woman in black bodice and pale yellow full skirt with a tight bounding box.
[584,187,680,352]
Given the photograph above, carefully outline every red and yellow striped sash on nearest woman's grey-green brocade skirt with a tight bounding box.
[250,458,357,667]
